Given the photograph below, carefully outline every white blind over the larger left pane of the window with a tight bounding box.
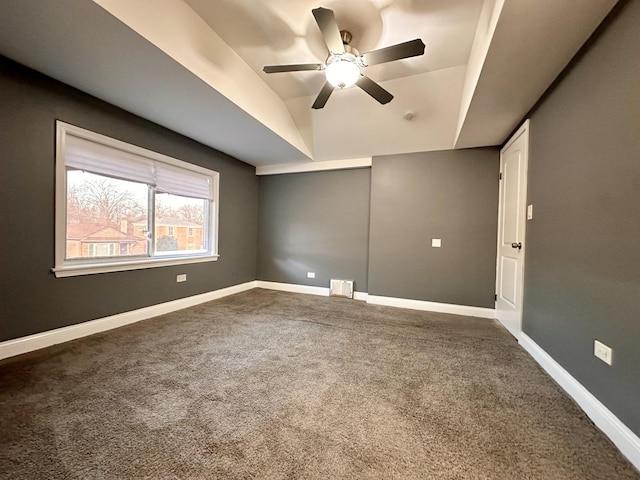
[65,133,155,185]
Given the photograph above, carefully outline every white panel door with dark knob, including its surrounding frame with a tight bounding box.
[496,120,529,339]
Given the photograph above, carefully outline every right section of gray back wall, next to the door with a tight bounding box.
[369,148,500,308]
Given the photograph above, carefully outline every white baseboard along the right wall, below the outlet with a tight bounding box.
[520,333,640,470]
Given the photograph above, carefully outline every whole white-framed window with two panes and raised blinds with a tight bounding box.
[53,122,219,277]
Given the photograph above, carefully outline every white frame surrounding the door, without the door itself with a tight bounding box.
[494,119,530,341]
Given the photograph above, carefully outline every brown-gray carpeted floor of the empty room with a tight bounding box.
[0,289,640,480]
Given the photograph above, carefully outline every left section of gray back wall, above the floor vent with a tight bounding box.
[257,168,370,292]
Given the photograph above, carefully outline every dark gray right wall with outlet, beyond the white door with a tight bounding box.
[523,1,640,435]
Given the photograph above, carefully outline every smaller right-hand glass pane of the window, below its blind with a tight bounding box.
[155,193,208,255]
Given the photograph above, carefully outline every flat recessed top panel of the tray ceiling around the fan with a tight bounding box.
[185,0,483,100]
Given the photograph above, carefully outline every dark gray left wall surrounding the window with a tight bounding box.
[0,57,258,341]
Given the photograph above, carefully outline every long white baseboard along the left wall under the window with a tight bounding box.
[0,281,256,360]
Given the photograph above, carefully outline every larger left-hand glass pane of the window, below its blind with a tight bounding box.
[66,170,149,259]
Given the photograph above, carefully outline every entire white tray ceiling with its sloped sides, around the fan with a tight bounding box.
[0,0,616,167]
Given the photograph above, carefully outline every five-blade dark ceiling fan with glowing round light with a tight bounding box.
[263,7,425,109]
